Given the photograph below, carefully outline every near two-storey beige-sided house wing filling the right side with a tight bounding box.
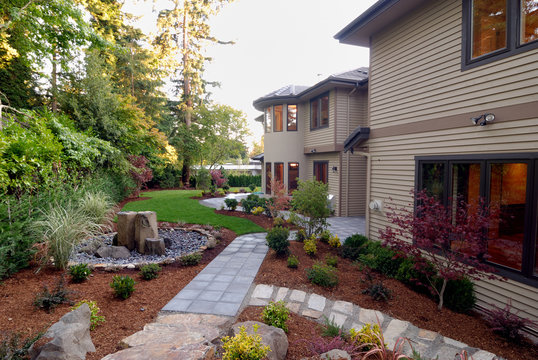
[335,0,538,320]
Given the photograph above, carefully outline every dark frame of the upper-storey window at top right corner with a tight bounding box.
[461,0,538,71]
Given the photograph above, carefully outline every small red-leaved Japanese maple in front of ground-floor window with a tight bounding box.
[380,190,498,310]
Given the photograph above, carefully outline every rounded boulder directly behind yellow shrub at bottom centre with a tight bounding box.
[232,321,288,360]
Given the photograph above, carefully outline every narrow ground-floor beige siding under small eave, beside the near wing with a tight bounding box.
[340,152,366,216]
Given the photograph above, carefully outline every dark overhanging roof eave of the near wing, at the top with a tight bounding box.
[334,0,425,47]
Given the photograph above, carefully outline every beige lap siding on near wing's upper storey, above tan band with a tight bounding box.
[370,0,538,129]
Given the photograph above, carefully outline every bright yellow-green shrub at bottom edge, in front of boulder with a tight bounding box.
[222,325,271,360]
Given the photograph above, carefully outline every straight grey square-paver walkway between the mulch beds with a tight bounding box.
[162,233,268,316]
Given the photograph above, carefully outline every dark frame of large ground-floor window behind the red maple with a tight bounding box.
[415,153,538,288]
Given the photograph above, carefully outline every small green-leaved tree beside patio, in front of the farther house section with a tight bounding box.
[290,180,331,237]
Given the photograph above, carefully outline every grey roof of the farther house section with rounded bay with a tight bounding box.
[253,67,368,110]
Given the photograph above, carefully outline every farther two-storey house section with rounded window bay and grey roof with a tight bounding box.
[253,68,368,216]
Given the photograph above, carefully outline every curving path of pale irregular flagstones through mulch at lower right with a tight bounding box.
[248,284,500,360]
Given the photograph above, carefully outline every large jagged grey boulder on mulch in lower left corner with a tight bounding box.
[29,304,95,360]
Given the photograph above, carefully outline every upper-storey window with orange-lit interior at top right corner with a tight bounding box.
[462,0,538,69]
